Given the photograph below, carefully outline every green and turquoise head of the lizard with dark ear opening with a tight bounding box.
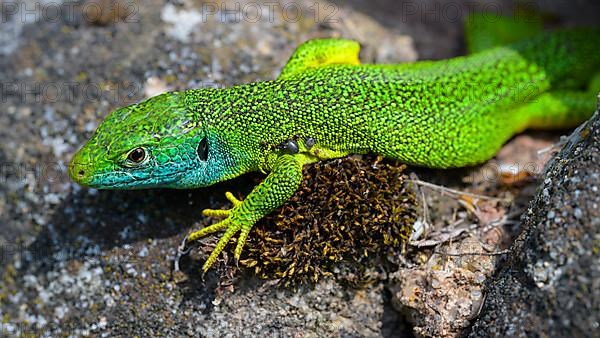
[69,92,237,189]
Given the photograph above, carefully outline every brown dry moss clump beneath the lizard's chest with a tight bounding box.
[240,157,416,285]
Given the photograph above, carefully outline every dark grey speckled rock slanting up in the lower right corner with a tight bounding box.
[466,107,600,337]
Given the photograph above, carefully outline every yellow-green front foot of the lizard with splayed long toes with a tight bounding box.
[187,192,254,272]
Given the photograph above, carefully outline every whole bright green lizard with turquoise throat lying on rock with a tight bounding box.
[69,17,600,271]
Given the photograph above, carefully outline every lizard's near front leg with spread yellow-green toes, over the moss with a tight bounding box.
[187,154,305,272]
